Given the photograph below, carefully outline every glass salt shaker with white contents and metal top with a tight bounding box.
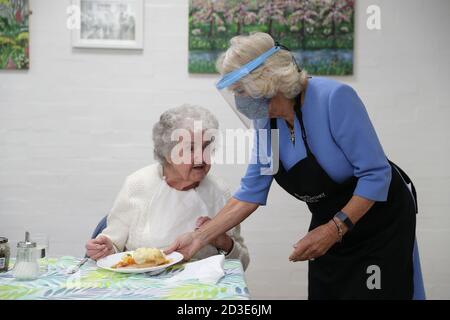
[13,231,39,280]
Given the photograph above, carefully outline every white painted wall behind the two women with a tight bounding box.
[0,0,450,299]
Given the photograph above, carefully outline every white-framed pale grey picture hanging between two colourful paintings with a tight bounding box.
[72,0,144,49]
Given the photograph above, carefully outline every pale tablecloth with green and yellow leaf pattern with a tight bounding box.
[0,256,250,300]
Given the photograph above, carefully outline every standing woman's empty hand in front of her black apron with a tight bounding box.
[289,221,339,262]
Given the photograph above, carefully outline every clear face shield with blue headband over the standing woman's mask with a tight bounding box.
[216,45,283,128]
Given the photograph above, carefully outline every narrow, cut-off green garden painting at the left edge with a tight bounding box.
[0,0,30,69]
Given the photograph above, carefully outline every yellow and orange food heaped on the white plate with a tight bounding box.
[112,248,170,269]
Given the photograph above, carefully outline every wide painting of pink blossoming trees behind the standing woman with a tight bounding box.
[189,0,354,75]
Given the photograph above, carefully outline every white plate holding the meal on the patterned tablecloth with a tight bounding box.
[97,251,183,273]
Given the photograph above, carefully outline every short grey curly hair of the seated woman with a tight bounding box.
[153,104,219,164]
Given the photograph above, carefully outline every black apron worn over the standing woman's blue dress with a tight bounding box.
[271,95,417,299]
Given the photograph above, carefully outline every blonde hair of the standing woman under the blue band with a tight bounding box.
[216,32,307,99]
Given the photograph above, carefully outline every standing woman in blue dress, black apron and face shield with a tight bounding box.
[167,33,417,299]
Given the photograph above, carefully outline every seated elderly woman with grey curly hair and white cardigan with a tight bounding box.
[86,105,249,268]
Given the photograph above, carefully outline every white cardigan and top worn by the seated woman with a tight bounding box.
[99,164,249,269]
